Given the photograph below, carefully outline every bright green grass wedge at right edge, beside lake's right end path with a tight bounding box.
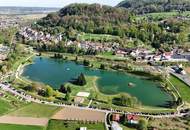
[170,76,190,103]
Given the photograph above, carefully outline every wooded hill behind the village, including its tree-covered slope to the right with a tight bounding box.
[33,4,189,48]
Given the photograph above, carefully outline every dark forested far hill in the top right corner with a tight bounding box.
[117,0,190,14]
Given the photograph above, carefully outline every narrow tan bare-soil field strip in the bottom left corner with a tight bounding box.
[0,116,48,126]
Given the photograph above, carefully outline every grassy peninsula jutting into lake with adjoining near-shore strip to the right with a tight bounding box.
[65,76,175,113]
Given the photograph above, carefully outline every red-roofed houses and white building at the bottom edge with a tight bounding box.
[111,114,139,130]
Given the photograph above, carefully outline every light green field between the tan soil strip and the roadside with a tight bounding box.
[9,103,59,118]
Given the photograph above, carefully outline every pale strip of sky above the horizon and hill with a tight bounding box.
[0,0,122,7]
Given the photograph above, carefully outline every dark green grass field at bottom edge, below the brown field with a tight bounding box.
[47,120,105,130]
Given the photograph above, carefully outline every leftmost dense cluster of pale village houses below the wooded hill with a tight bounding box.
[19,27,62,44]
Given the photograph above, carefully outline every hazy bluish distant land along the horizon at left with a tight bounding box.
[0,6,59,15]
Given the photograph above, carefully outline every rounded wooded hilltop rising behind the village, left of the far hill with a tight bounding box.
[35,4,131,35]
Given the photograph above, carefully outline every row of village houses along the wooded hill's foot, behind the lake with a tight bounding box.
[19,27,190,62]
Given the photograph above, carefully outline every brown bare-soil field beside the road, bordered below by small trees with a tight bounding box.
[52,108,105,122]
